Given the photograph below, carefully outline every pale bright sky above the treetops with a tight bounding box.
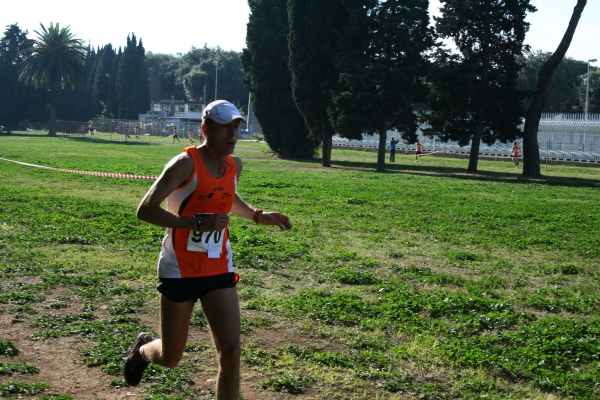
[0,0,600,65]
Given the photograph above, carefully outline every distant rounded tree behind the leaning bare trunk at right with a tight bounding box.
[518,50,587,112]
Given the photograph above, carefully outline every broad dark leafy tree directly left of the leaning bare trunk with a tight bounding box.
[424,0,535,171]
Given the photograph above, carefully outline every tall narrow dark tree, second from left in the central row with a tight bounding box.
[288,0,348,167]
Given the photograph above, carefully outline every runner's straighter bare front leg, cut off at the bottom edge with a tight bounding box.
[202,288,242,400]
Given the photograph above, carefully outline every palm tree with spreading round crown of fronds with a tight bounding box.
[19,22,87,136]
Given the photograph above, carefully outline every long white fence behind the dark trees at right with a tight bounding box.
[333,114,600,163]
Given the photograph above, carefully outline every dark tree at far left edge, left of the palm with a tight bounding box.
[0,24,48,133]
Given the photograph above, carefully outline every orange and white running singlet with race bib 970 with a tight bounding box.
[158,146,238,278]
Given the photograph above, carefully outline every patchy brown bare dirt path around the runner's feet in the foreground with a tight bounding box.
[0,313,336,400]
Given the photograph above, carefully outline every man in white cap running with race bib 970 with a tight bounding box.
[123,100,291,400]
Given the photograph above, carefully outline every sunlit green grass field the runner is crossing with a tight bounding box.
[0,132,600,400]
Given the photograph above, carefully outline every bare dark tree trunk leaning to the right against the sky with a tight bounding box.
[523,0,587,176]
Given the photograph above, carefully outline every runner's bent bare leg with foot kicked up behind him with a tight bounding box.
[143,294,195,368]
